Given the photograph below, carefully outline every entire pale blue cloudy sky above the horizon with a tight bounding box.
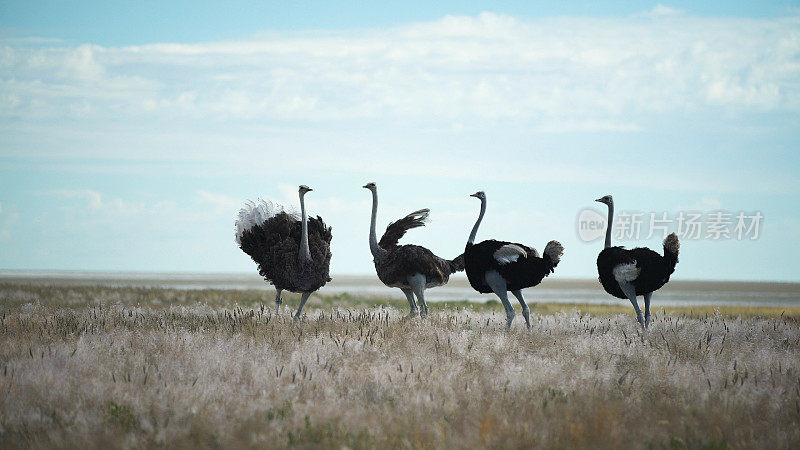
[0,1,800,281]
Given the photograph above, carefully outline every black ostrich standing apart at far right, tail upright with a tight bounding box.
[595,195,680,328]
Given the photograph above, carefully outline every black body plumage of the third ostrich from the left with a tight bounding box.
[464,239,558,294]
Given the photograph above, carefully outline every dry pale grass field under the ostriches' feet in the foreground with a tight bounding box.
[0,283,800,448]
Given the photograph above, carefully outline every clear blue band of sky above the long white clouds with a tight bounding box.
[6,0,800,45]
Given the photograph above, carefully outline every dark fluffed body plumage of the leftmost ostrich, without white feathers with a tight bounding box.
[239,212,332,292]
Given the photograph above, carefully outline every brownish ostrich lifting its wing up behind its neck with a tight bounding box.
[363,183,464,317]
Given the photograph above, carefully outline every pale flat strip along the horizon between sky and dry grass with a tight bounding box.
[0,270,800,306]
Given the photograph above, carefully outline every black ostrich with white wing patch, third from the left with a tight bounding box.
[464,191,564,328]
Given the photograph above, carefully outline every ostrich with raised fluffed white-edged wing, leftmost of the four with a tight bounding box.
[236,185,331,318]
